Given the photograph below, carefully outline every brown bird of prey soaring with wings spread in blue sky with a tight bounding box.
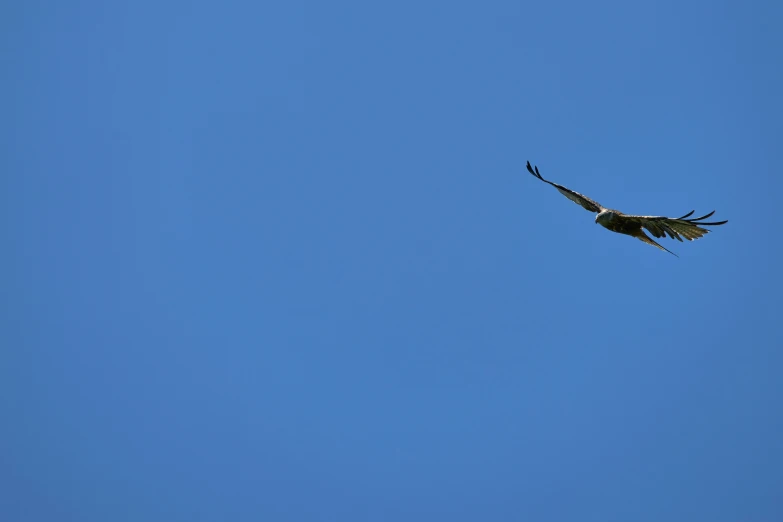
[527,161,728,257]
